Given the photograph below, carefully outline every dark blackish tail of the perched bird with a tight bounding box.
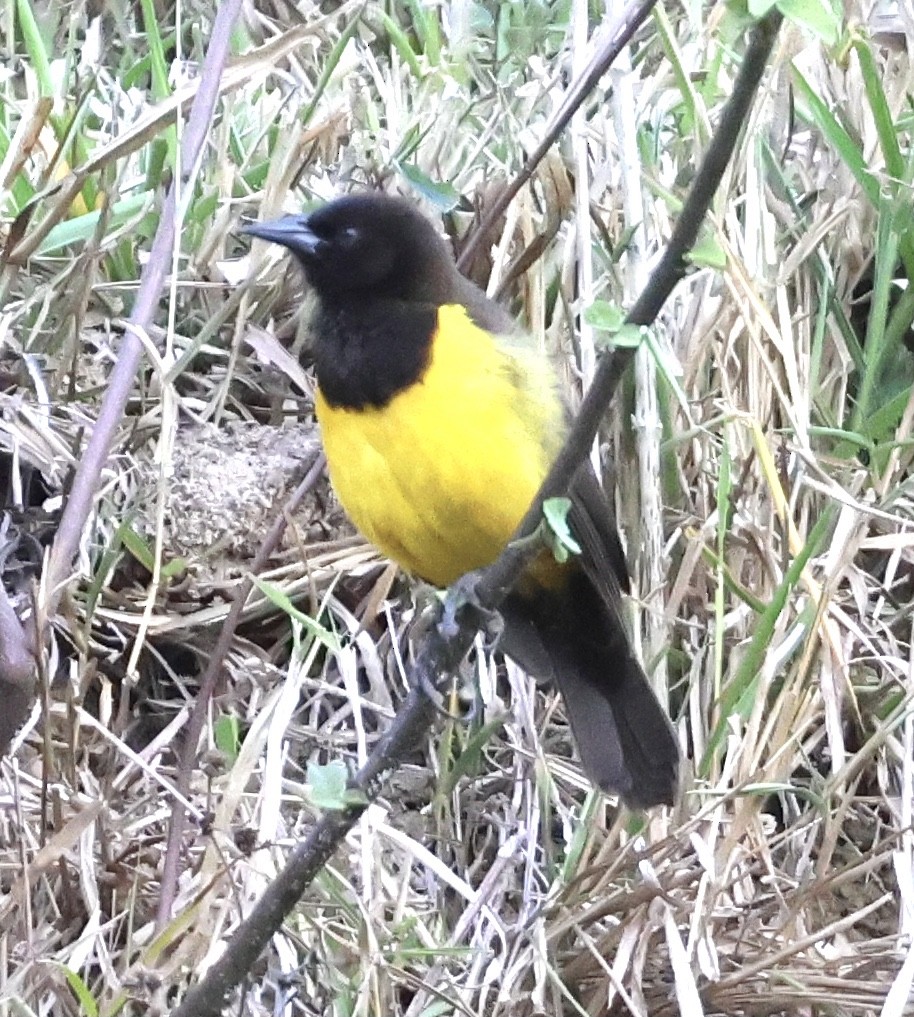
[502,571,679,809]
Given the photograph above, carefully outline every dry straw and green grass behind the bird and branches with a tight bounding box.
[0,0,914,1017]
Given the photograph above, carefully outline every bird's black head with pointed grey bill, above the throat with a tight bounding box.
[244,191,459,304]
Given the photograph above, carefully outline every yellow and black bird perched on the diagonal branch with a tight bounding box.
[246,192,679,809]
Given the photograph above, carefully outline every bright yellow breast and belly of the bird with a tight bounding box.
[316,305,564,586]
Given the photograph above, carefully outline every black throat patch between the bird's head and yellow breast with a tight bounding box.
[311,297,438,410]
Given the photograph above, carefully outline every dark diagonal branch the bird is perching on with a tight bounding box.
[164,11,781,1017]
